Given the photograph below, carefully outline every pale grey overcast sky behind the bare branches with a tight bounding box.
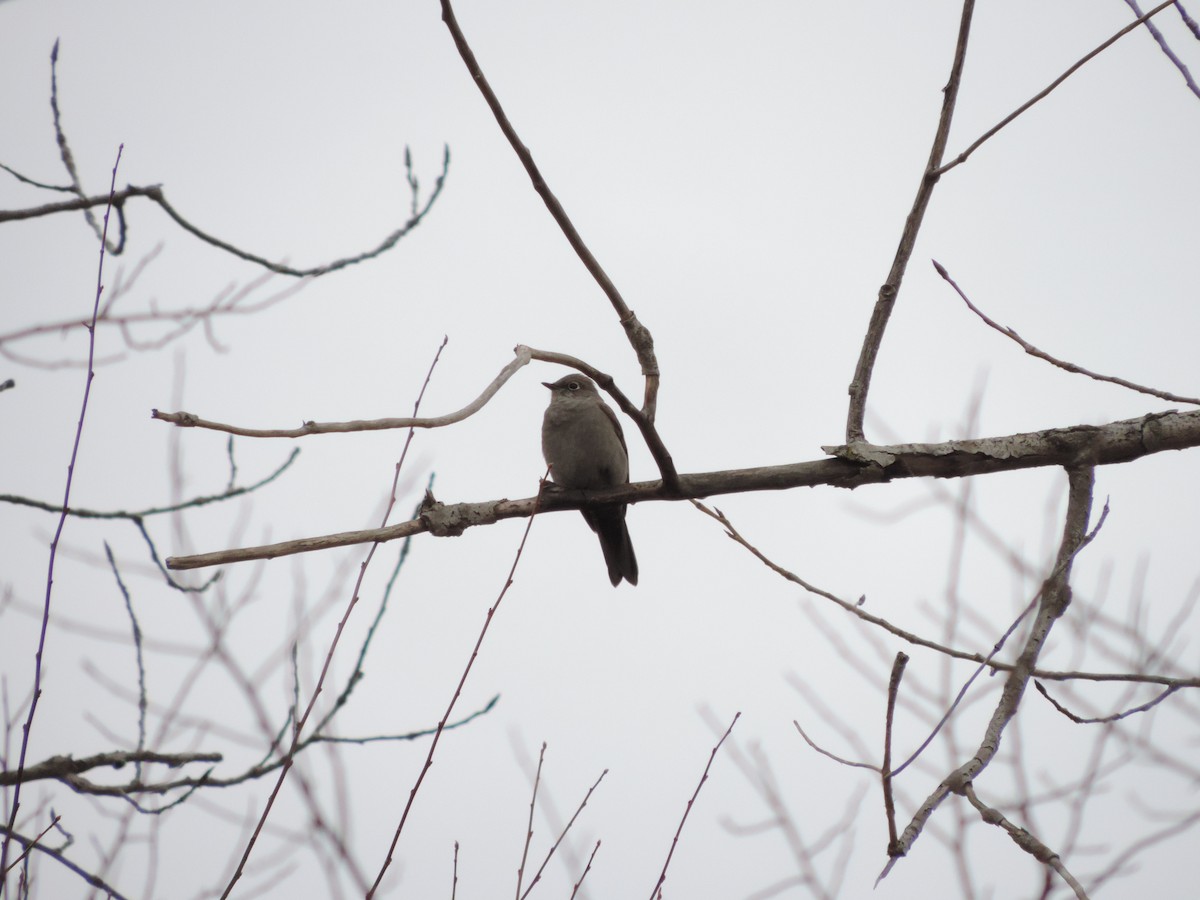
[0,0,1200,898]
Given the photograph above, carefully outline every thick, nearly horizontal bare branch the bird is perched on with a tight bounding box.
[167,412,1200,569]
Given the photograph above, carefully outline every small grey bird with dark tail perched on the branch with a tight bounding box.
[541,373,637,587]
